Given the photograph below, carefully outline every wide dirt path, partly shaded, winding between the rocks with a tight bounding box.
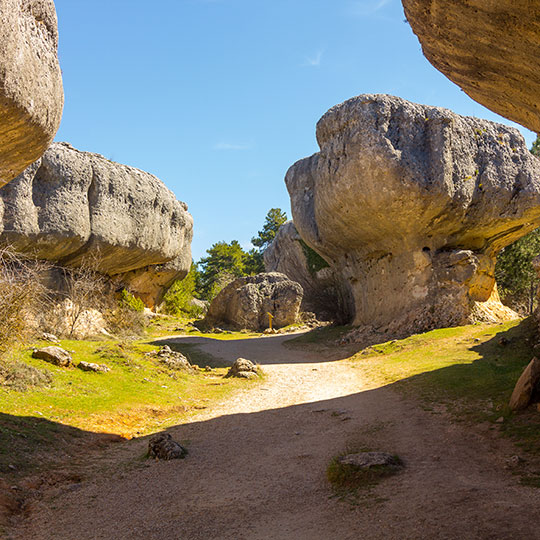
[10,336,540,540]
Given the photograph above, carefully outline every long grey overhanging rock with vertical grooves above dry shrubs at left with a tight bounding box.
[0,143,193,307]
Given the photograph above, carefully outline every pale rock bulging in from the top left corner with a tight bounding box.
[0,0,64,187]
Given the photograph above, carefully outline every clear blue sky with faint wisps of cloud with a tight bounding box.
[55,0,535,260]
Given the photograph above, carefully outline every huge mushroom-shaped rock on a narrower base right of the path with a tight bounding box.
[286,95,540,332]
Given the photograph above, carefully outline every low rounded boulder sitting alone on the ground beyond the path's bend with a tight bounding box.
[205,272,303,330]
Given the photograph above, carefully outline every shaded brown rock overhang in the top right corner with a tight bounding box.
[403,0,540,133]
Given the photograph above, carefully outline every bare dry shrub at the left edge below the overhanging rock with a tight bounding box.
[0,247,48,355]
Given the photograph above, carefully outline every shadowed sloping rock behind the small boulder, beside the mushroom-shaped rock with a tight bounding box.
[264,221,350,322]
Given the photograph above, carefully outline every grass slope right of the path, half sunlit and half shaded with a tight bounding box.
[351,319,540,455]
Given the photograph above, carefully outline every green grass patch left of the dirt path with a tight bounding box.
[0,340,256,475]
